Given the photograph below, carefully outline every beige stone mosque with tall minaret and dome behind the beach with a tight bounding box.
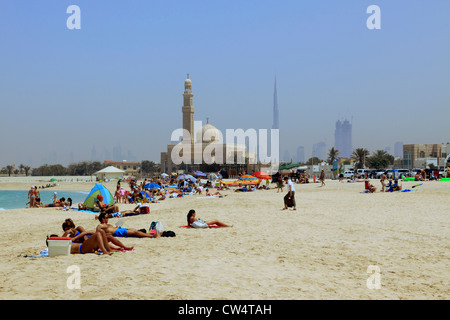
[161,74,257,176]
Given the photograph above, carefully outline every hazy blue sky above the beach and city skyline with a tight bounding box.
[0,0,450,167]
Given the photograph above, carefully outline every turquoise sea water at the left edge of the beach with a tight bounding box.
[0,189,89,210]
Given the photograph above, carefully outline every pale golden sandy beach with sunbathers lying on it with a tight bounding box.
[0,178,450,300]
